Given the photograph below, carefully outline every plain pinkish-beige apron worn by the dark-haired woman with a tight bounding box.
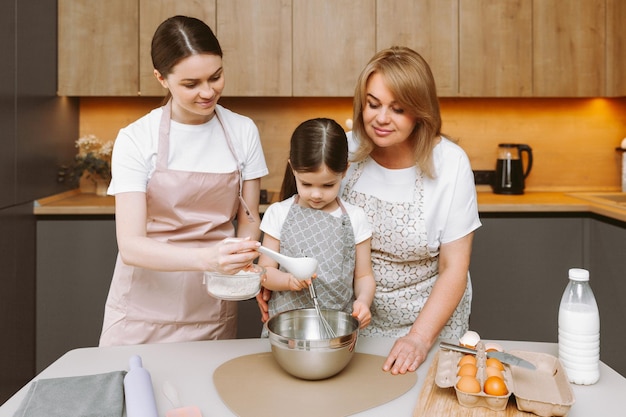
[100,102,242,346]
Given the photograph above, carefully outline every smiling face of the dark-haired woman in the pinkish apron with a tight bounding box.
[154,54,224,124]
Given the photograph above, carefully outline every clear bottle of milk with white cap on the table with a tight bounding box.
[559,268,600,385]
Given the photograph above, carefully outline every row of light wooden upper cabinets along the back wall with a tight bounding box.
[58,0,626,97]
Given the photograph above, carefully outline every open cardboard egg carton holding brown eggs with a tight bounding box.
[435,349,575,417]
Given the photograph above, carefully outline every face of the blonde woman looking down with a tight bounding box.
[363,73,417,161]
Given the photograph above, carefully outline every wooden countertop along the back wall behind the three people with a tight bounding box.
[33,187,626,222]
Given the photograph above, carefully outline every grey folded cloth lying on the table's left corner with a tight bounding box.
[14,371,126,417]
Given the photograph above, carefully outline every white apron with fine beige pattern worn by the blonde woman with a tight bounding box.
[342,157,472,340]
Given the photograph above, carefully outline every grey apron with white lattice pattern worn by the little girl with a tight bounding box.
[269,197,356,316]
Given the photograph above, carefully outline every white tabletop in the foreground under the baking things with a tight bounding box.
[0,337,626,417]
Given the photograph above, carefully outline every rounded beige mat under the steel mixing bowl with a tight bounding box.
[213,352,417,417]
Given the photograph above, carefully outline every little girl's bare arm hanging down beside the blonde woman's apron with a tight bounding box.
[352,238,376,328]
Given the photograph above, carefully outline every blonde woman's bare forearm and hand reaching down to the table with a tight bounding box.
[383,232,474,374]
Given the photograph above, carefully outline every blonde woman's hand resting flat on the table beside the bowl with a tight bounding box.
[383,333,430,375]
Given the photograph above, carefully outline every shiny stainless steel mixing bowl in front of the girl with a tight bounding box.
[266,308,359,380]
